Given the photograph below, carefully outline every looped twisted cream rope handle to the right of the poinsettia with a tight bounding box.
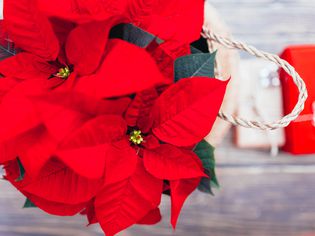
[202,27,308,130]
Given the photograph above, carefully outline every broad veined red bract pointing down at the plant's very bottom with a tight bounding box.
[95,159,163,236]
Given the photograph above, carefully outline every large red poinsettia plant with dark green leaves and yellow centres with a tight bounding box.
[0,0,227,236]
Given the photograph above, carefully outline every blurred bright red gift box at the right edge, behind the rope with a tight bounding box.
[280,45,315,154]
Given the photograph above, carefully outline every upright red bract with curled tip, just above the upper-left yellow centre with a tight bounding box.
[66,18,117,75]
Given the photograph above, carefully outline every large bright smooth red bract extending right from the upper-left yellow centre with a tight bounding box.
[75,39,165,98]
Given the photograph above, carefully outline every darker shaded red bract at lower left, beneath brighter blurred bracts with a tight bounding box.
[19,159,103,205]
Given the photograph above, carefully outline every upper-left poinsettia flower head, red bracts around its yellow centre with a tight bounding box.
[0,0,170,170]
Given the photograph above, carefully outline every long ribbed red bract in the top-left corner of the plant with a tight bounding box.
[4,0,59,61]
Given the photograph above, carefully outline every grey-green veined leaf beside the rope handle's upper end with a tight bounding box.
[175,49,216,82]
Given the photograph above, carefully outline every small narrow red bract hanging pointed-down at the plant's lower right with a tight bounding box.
[170,178,201,229]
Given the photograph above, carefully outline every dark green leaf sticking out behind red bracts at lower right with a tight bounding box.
[194,140,220,194]
